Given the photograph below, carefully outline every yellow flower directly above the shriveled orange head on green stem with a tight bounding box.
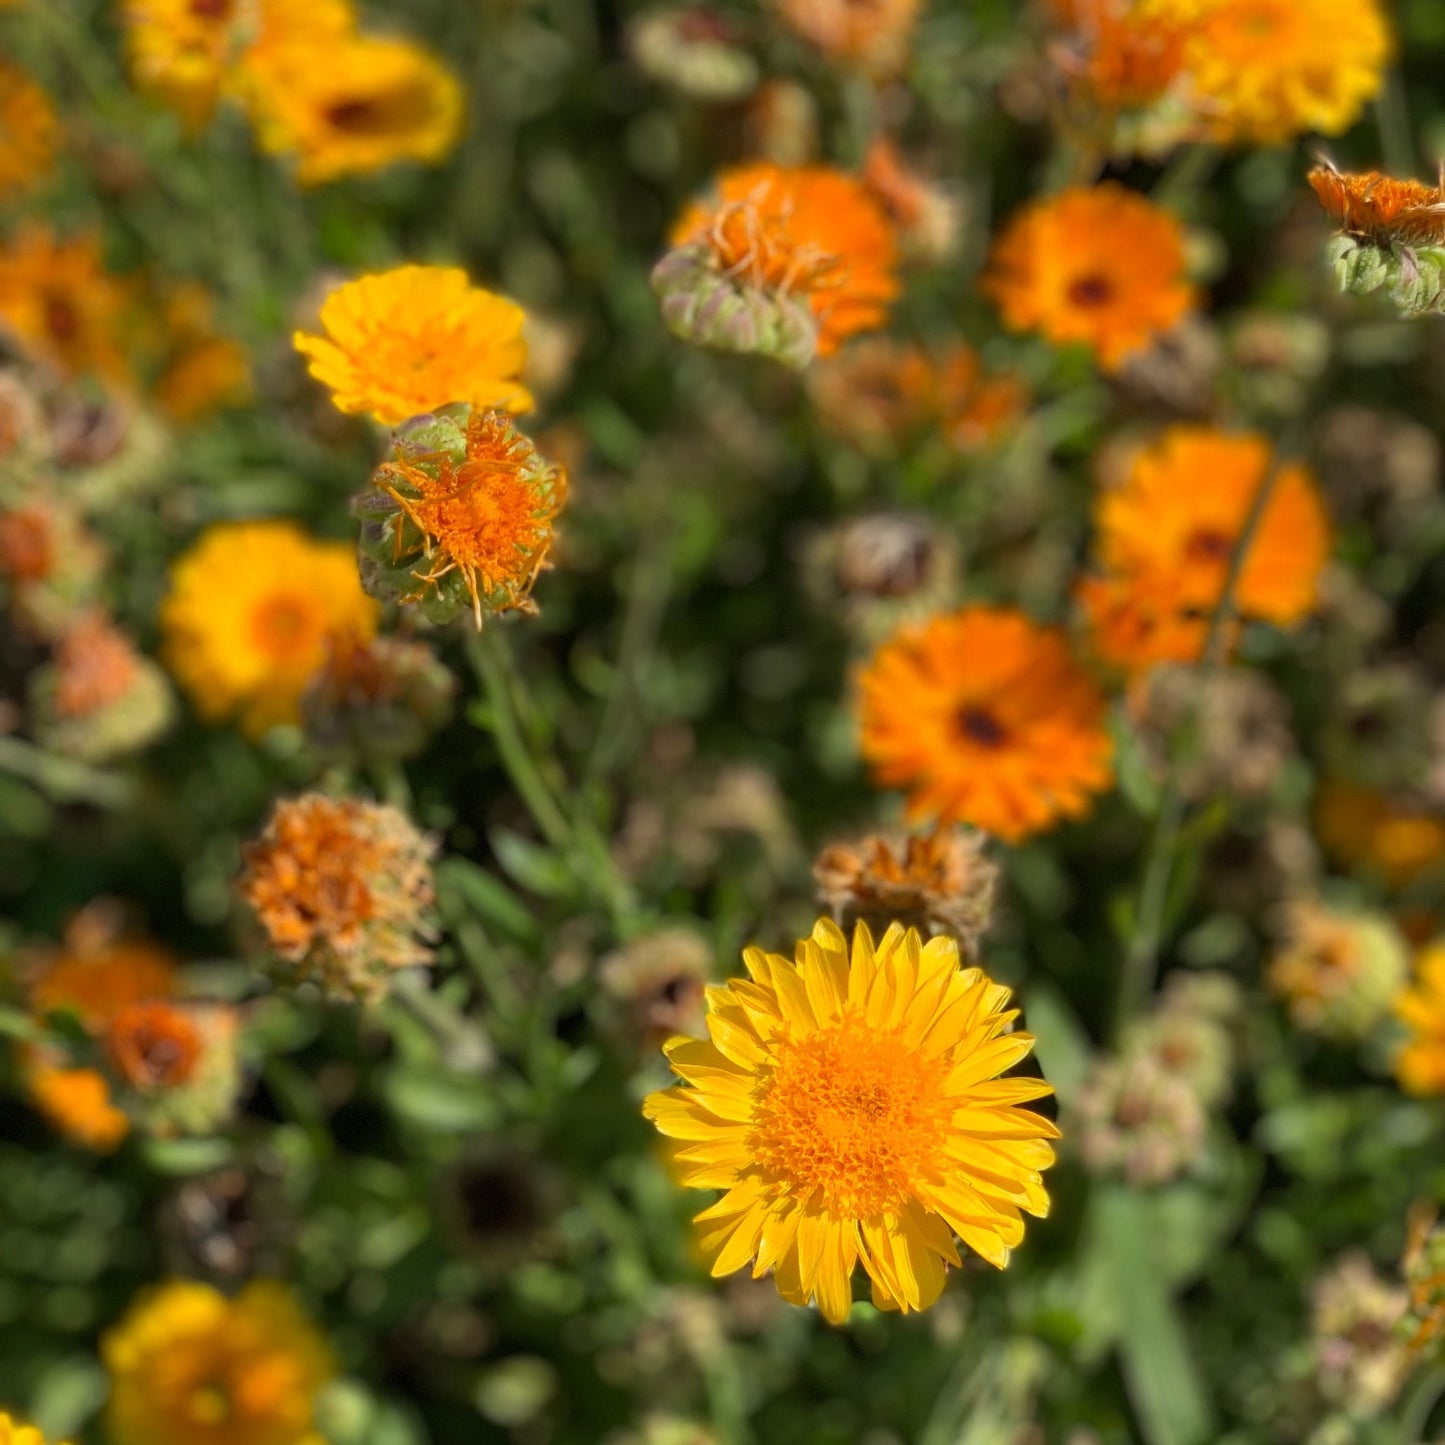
[292,266,532,426]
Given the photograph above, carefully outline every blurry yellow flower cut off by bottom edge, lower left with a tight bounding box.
[101,1280,335,1445]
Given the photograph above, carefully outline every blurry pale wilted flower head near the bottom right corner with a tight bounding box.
[1311,1250,1409,1416]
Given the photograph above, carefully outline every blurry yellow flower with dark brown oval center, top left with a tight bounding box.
[244,36,464,185]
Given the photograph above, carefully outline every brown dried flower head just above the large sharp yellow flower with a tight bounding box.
[814,828,998,958]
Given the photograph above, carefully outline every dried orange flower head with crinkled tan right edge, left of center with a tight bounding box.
[240,793,435,1001]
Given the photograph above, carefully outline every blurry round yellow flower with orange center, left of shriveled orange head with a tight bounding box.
[160,520,377,736]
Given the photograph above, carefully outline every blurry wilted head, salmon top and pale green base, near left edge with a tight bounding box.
[29,613,175,763]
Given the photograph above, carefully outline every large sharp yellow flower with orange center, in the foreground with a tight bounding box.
[643,920,1058,1324]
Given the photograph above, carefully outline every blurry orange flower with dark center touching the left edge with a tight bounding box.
[0,227,129,381]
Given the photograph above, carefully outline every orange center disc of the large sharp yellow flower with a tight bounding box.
[749,1014,954,1220]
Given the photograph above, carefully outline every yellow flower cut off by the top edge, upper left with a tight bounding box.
[120,0,253,130]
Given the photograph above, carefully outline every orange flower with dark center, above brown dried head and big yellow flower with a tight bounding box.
[860,607,1113,842]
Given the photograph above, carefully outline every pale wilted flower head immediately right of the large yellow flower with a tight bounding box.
[1074,1051,1207,1185]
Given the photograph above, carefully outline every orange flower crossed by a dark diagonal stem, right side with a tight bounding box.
[1097,426,1331,627]
